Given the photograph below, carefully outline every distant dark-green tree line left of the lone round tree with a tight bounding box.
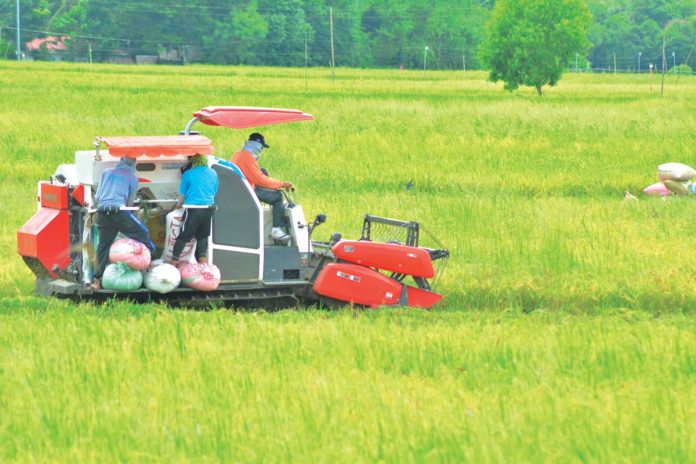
[0,0,493,69]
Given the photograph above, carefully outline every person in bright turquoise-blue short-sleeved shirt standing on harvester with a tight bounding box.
[169,155,218,265]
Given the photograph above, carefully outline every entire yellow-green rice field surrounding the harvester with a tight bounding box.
[0,61,696,462]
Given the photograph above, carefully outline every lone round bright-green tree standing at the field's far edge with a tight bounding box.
[480,0,591,95]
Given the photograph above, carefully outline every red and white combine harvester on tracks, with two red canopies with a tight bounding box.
[17,107,449,309]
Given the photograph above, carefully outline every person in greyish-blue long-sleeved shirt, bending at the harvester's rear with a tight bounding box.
[92,157,155,290]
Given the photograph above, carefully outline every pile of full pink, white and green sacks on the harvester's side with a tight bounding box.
[102,210,220,293]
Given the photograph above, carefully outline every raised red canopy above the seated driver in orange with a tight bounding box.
[193,106,314,129]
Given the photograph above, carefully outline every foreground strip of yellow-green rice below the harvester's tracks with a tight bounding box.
[0,303,696,462]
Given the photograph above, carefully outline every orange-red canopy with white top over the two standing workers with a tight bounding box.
[99,135,214,158]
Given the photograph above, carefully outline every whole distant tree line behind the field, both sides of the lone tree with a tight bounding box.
[0,0,696,70]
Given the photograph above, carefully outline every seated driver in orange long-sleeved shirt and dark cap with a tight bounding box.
[231,132,292,242]
